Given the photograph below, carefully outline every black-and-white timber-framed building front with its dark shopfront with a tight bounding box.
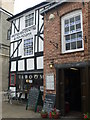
[7,2,54,98]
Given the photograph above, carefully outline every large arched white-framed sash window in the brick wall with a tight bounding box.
[61,10,83,53]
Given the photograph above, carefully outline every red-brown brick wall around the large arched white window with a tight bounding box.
[44,2,90,95]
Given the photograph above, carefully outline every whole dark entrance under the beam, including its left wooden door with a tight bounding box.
[56,68,81,115]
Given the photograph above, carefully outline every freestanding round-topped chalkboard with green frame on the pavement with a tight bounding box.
[26,87,39,112]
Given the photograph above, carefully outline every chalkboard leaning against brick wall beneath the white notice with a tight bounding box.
[43,94,56,114]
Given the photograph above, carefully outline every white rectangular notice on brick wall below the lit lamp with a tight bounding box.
[46,73,54,90]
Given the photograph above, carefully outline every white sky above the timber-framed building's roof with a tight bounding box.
[14,0,45,14]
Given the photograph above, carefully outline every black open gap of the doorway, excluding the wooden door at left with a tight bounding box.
[64,68,81,113]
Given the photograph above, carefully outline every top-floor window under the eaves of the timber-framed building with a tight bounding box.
[25,13,34,27]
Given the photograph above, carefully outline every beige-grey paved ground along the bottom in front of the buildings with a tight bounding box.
[2,94,82,120]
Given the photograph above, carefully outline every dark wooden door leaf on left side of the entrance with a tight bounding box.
[56,69,65,115]
